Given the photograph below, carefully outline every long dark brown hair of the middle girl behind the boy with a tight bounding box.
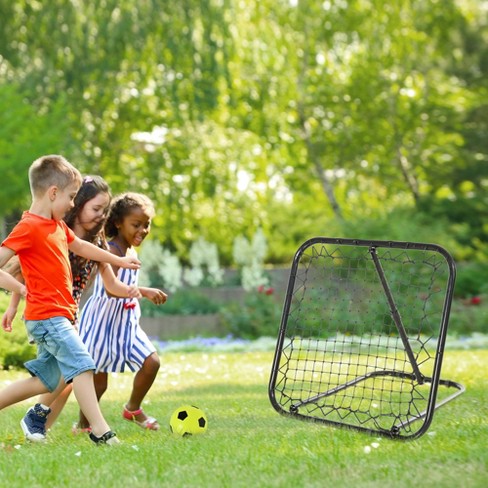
[63,175,112,276]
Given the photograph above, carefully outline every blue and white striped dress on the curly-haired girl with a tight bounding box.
[79,262,156,373]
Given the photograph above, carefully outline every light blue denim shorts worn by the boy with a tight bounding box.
[25,317,95,391]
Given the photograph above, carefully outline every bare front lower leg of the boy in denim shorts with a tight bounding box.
[73,371,110,437]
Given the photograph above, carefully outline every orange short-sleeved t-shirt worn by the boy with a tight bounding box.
[2,212,77,321]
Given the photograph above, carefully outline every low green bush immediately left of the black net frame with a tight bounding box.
[221,286,281,339]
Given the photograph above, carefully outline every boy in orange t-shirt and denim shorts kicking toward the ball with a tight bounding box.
[0,155,140,445]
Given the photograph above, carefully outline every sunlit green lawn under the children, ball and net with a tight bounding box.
[0,350,488,488]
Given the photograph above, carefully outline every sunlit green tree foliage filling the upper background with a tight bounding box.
[0,0,488,265]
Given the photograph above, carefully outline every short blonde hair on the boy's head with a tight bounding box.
[29,154,82,196]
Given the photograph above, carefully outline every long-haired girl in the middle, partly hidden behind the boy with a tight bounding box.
[2,176,142,442]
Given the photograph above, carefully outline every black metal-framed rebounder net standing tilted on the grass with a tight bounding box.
[269,237,464,439]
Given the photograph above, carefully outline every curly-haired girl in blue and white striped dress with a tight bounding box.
[79,193,166,430]
